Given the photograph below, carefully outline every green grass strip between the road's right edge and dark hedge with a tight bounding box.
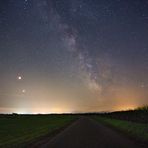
[94,116,148,142]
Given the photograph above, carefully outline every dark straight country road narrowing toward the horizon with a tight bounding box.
[30,117,146,148]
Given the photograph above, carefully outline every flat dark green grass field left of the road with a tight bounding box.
[0,115,76,147]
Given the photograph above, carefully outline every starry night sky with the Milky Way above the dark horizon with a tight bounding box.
[0,0,148,113]
